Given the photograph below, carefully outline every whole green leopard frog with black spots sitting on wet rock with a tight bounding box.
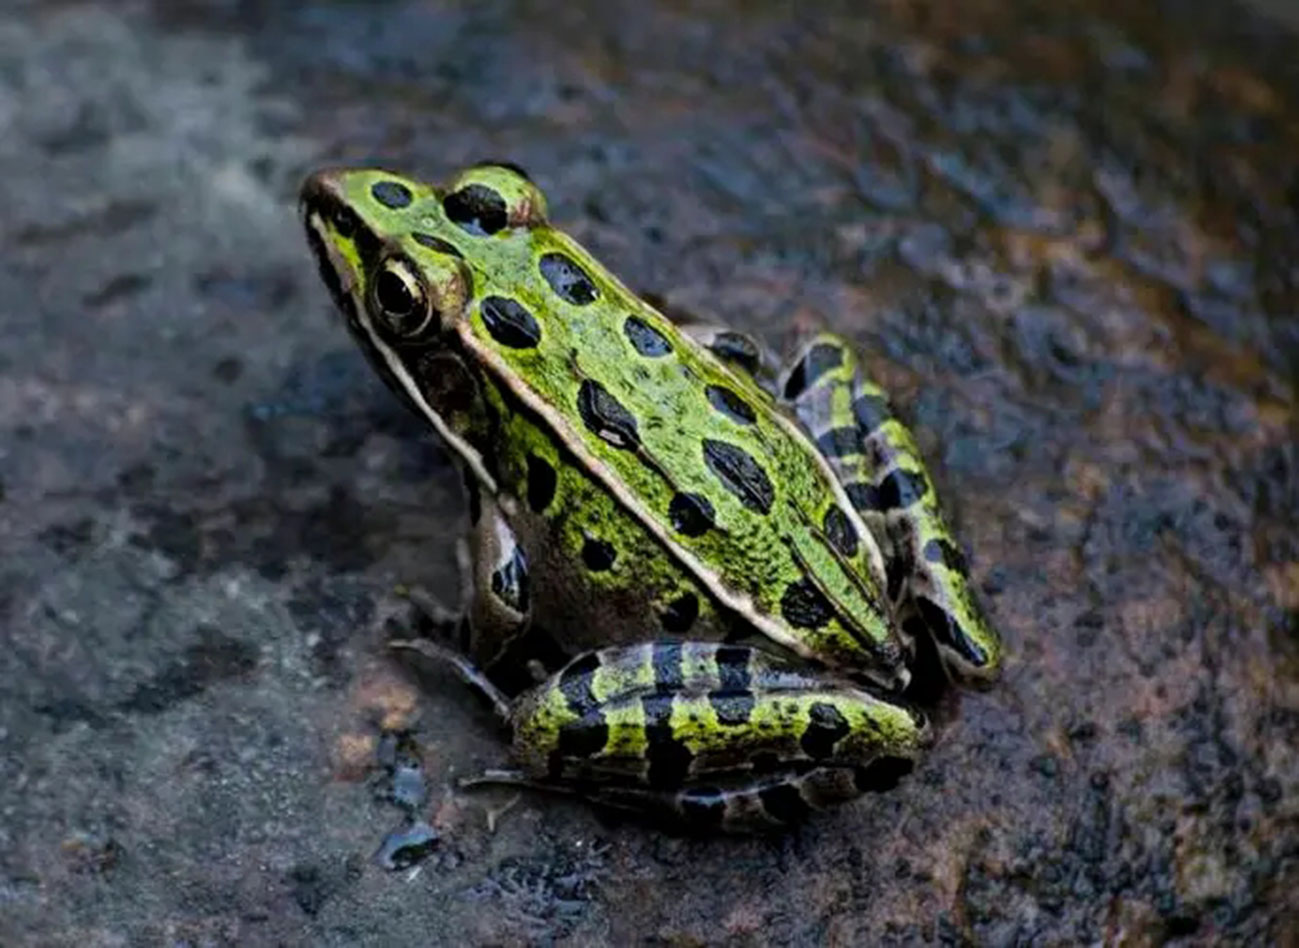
[301,165,1000,830]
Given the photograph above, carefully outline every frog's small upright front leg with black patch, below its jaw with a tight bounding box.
[468,496,531,666]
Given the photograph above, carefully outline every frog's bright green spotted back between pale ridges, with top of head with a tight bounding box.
[315,166,904,684]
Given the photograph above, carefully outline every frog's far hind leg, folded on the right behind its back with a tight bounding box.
[778,332,1002,680]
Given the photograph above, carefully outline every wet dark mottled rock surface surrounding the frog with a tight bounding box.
[0,0,1299,945]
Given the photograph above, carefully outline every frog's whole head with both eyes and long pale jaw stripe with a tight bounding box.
[300,165,546,484]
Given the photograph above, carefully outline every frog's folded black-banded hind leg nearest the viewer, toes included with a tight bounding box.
[441,642,929,831]
